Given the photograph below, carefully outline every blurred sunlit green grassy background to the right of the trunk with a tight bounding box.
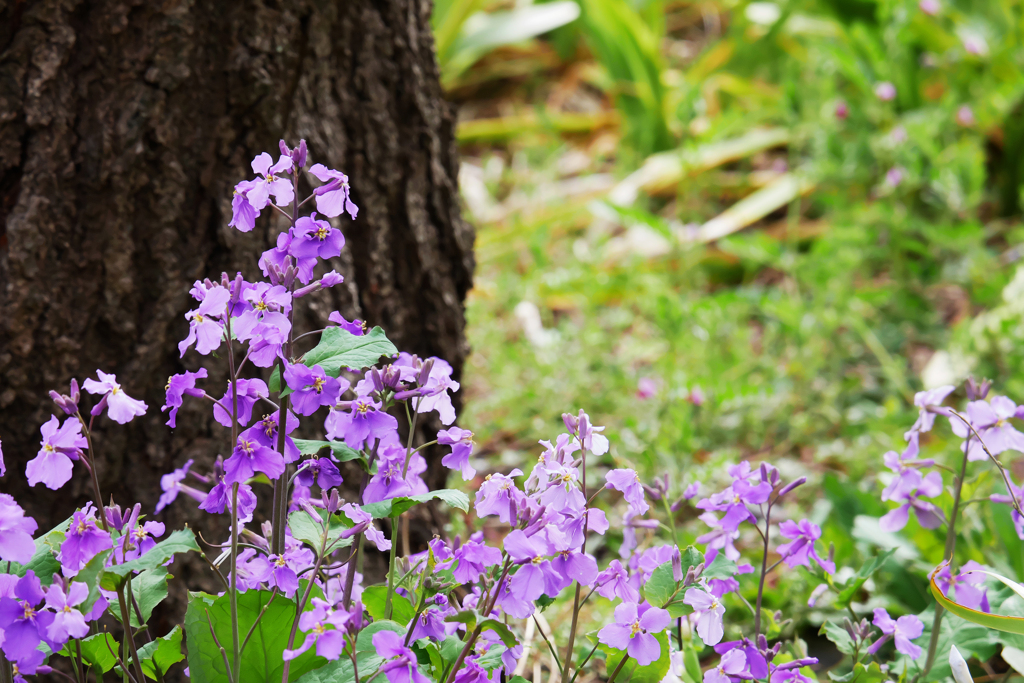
[442,0,1024,655]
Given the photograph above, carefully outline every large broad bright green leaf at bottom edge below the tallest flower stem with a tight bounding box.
[185,588,326,683]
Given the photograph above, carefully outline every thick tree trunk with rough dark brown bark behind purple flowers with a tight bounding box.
[0,0,473,630]
